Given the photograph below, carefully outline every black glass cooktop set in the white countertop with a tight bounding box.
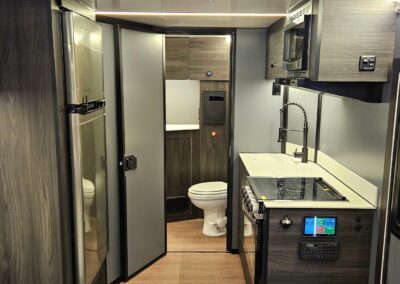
[248,177,346,201]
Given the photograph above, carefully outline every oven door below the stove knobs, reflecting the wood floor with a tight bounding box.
[242,205,263,284]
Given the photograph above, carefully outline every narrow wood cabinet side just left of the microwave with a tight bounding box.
[265,19,287,79]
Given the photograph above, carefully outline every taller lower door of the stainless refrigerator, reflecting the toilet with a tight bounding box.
[70,109,108,283]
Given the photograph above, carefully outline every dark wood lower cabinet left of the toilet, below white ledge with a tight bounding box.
[165,130,200,221]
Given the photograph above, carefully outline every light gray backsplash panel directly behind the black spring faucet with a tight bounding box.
[287,87,318,149]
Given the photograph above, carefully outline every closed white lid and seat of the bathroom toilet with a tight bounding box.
[188,181,227,200]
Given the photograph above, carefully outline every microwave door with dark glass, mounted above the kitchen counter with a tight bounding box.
[283,15,311,71]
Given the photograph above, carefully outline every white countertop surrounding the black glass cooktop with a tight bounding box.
[240,153,376,209]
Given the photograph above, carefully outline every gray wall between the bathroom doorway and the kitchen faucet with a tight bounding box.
[232,29,282,248]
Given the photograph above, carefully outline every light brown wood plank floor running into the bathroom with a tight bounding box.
[127,219,245,284]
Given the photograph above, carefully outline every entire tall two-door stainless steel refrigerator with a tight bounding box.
[62,12,108,283]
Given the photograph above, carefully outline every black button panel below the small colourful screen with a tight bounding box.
[299,241,339,261]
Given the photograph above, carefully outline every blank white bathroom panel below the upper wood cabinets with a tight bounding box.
[165,80,200,124]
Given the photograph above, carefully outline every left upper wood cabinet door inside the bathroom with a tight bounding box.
[165,37,189,80]
